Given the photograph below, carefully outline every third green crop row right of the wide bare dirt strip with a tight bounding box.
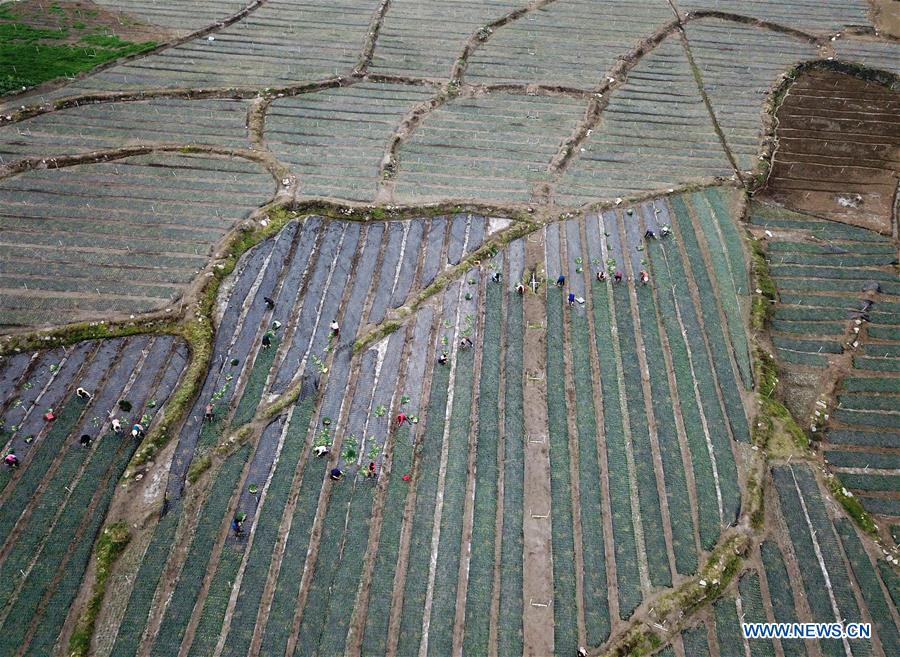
[588,281,643,619]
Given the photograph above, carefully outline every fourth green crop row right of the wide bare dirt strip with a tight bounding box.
[613,286,672,586]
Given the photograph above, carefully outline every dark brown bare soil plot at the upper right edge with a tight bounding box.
[766,66,900,235]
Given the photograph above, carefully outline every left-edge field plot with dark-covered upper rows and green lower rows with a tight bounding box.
[0,336,187,655]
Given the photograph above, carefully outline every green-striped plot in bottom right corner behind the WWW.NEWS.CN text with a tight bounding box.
[656,465,900,657]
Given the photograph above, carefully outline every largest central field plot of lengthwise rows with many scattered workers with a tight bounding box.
[74,190,764,655]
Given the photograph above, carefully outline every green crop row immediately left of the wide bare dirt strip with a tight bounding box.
[497,294,525,655]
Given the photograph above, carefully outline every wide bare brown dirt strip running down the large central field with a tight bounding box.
[522,233,554,657]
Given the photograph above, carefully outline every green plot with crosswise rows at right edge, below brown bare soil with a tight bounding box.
[751,205,900,517]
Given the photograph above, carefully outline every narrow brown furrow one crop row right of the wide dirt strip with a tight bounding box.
[559,224,588,646]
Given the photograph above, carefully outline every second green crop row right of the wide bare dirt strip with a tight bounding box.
[569,311,611,645]
